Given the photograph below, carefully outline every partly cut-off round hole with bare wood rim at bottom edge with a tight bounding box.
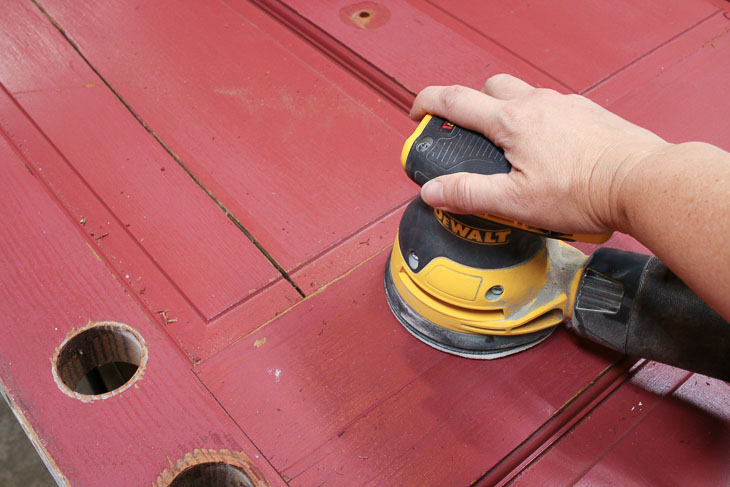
[153,449,269,487]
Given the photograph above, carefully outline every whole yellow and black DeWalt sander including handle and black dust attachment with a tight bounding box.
[385,115,730,380]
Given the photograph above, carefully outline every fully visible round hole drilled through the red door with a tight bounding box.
[53,321,147,400]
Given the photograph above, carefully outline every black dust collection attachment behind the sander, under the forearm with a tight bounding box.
[568,247,730,381]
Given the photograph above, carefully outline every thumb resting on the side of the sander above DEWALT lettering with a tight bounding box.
[421,173,514,214]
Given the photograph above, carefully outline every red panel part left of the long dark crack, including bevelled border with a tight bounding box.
[0,0,300,360]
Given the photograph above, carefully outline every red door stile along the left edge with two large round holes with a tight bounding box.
[0,132,284,486]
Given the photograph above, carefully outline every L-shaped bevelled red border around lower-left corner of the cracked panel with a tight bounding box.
[0,85,301,362]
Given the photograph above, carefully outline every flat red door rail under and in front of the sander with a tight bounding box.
[198,252,616,485]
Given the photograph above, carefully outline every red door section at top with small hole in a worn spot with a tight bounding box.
[274,0,719,92]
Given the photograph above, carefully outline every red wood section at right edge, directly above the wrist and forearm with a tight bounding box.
[588,13,730,150]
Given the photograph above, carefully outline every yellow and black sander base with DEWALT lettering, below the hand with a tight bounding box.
[385,194,587,359]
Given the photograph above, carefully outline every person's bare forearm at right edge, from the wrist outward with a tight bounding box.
[614,142,730,321]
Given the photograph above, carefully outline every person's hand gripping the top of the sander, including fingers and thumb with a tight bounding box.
[411,74,671,233]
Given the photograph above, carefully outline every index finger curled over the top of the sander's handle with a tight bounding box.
[410,85,505,137]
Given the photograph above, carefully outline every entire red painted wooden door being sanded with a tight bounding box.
[0,0,730,486]
